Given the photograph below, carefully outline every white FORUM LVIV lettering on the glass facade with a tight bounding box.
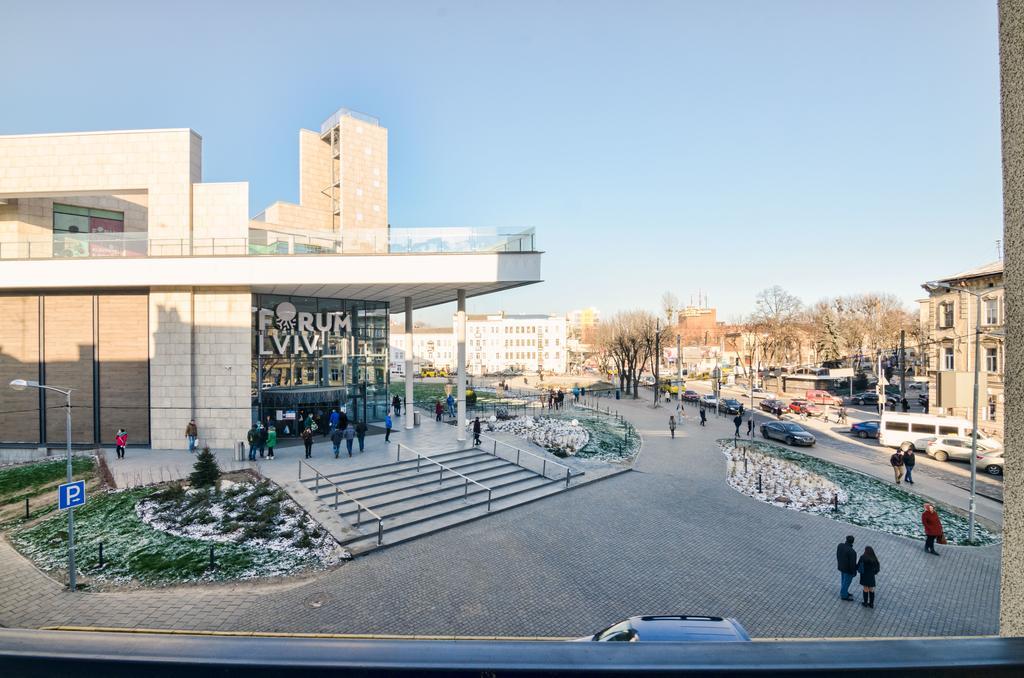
[256,301,352,355]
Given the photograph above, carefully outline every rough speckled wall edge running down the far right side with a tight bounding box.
[999,0,1024,636]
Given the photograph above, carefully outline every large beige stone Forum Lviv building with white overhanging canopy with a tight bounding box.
[0,109,541,449]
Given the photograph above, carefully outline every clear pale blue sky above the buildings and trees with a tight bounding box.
[0,0,1001,319]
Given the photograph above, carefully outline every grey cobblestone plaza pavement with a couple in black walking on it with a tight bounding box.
[0,395,999,637]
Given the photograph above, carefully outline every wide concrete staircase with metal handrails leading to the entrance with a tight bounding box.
[301,448,582,553]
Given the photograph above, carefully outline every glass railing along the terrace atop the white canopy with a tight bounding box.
[0,224,537,259]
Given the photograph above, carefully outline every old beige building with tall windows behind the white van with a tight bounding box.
[919,261,1006,438]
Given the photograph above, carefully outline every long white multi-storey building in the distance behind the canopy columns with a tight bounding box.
[390,312,568,375]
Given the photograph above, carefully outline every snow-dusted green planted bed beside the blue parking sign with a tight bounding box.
[11,482,341,586]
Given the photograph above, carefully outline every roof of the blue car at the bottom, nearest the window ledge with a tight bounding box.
[577,615,751,643]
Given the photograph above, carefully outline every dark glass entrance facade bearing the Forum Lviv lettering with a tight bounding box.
[252,294,388,435]
